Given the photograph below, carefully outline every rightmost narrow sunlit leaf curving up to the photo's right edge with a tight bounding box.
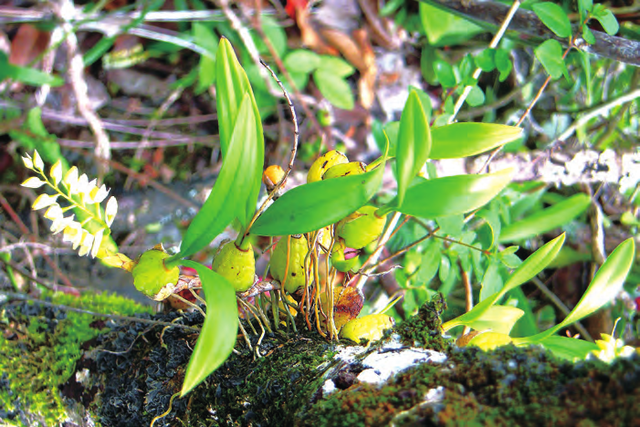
[514,238,635,345]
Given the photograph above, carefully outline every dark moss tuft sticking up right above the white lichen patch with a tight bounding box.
[396,293,452,352]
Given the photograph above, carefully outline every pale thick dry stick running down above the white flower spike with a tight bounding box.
[56,0,111,175]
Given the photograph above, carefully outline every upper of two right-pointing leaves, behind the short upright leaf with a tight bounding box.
[429,123,522,159]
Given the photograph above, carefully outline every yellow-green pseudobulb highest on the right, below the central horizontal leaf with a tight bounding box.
[336,206,387,249]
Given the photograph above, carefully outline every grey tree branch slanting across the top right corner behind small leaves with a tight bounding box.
[419,0,640,66]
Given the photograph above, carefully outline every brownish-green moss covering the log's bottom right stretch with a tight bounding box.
[302,346,640,426]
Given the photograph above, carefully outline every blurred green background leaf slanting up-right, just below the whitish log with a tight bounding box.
[500,194,591,242]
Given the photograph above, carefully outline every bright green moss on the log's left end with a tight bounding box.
[0,293,150,425]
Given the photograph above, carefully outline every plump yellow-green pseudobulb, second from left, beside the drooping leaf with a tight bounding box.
[211,242,256,292]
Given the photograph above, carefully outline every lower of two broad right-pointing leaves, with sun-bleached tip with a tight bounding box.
[396,169,513,218]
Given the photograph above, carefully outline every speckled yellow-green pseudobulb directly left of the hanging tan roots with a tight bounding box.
[271,234,309,294]
